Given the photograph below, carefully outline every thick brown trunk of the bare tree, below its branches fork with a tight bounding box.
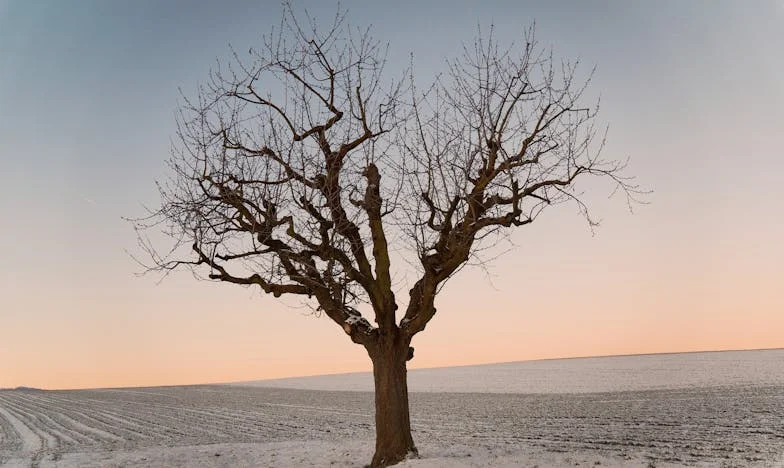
[370,333,417,468]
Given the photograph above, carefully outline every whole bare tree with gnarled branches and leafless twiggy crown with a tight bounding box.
[136,7,637,466]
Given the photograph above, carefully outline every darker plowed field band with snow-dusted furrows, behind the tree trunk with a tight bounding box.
[0,386,784,467]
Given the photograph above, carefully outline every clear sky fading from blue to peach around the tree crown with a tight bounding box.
[0,0,784,388]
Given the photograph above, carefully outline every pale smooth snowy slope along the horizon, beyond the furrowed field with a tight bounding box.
[237,349,784,393]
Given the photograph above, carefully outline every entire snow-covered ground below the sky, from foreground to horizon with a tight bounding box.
[0,350,784,467]
